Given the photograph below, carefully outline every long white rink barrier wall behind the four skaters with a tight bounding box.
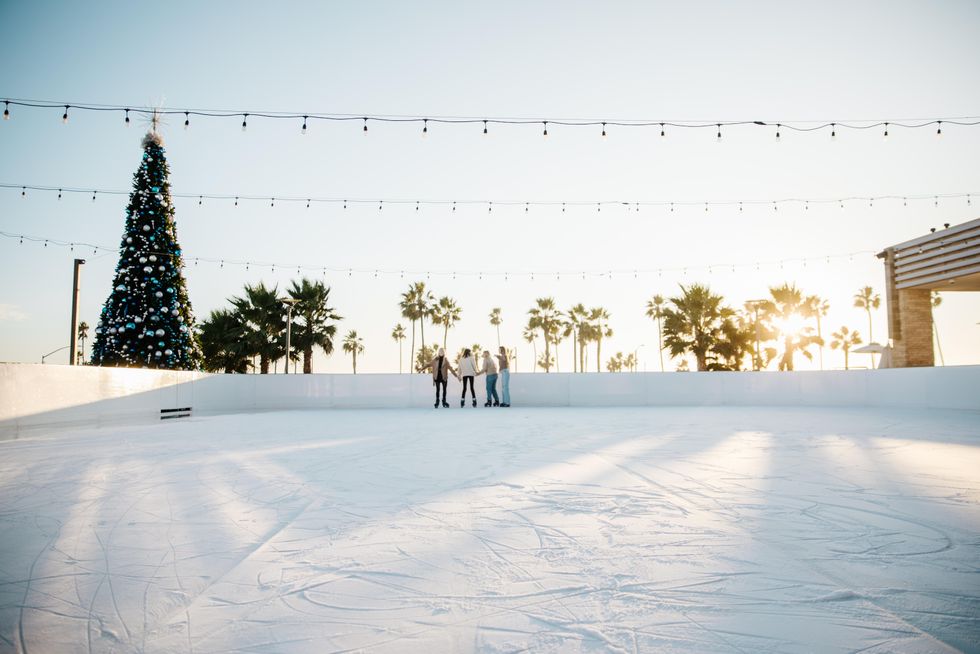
[0,364,980,439]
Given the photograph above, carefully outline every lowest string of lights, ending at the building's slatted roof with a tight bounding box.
[0,231,874,282]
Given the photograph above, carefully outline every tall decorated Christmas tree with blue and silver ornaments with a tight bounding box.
[92,120,200,370]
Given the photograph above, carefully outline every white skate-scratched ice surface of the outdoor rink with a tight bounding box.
[0,407,980,654]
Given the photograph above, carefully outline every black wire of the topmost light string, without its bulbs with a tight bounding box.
[4,98,980,132]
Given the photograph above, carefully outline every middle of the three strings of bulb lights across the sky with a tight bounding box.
[0,183,980,212]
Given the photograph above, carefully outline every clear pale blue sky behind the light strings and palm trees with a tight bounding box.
[0,1,980,372]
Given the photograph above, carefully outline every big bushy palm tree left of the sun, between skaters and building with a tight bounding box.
[663,284,734,371]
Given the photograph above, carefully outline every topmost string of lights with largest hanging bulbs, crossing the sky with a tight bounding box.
[3,98,980,140]
